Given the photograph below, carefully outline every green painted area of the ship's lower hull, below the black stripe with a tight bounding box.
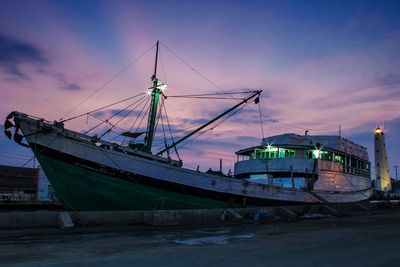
[37,154,232,211]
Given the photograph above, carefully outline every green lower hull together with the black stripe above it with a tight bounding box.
[34,143,312,211]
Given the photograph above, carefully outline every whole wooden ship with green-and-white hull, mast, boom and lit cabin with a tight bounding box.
[4,42,372,211]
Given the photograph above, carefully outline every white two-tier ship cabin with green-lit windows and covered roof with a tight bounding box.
[234,133,371,188]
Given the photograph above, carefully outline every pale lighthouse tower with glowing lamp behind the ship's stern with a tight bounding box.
[374,127,392,191]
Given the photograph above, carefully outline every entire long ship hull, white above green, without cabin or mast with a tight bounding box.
[5,113,372,210]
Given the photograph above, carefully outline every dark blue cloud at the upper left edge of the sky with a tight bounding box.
[0,34,49,80]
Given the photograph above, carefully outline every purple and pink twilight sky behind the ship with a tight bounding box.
[0,0,400,180]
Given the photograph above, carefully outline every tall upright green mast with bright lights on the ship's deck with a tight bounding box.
[145,41,162,153]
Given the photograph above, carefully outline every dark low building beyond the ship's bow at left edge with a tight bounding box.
[0,165,40,201]
